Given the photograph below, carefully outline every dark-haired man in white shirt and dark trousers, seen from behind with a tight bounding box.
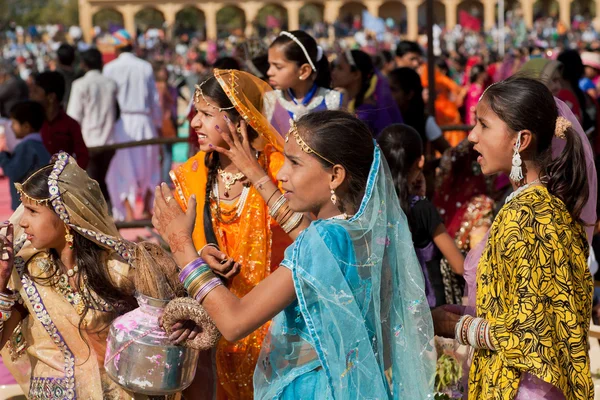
[67,49,119,206]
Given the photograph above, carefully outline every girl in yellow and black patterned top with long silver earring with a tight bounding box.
[435,77,596,400]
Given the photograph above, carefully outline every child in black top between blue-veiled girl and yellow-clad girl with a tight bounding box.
[377,124,464,307]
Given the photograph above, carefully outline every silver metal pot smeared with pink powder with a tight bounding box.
[104,295,200,396]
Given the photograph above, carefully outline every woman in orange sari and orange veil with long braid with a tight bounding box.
[171,69,307,400]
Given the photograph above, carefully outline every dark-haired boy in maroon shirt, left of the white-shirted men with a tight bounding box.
[29,72,90,169]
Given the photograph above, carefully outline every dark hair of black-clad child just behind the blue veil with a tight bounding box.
[377,124,423,226]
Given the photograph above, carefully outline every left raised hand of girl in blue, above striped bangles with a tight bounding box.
[152,182,198,266]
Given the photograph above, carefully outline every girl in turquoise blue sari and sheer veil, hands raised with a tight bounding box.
[154,111,435,399]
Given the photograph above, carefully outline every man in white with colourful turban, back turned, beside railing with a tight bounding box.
[104,29,162,221]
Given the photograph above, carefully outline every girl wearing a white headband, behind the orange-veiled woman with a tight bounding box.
[264,31,343,135]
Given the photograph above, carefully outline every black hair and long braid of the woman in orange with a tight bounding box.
[202,77,258,244]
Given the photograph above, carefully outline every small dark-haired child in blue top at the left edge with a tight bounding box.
[0,101,50,210]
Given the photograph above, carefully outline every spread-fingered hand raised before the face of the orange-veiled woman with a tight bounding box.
[209,116,265,183]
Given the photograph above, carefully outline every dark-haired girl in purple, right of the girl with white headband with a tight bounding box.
[332,50,402,137]
